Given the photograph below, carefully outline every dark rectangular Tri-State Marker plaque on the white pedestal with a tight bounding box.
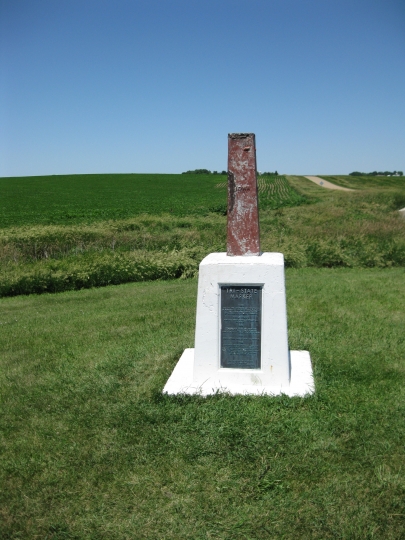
[221,285,262,369]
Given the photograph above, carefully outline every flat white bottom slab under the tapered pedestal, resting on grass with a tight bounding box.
[163,349,315,397]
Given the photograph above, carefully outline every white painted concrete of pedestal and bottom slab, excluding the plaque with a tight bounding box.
[163,253,314,395]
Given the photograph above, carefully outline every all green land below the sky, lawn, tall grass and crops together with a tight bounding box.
[0,175,405,540]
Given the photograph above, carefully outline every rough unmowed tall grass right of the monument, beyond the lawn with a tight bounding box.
[261,185,405,267]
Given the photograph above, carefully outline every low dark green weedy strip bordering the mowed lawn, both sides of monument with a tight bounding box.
[0,237,405,297]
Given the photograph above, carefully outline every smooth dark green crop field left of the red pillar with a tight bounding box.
[0,174,226,228]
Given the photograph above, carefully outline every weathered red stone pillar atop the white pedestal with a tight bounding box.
[227,133,260,255]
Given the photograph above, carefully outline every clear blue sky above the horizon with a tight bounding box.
[0,0,405,176]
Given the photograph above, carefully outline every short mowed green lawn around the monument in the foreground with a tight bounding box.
[0,268,405,540]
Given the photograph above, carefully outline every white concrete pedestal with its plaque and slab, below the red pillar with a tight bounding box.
[163,253,314,396]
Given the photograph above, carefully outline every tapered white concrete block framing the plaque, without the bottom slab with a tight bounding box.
[193,253,290,387]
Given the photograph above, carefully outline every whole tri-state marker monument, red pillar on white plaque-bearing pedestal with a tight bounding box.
[163,133,315,396]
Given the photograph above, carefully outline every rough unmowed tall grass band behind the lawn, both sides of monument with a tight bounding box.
[0,175,405,296]
